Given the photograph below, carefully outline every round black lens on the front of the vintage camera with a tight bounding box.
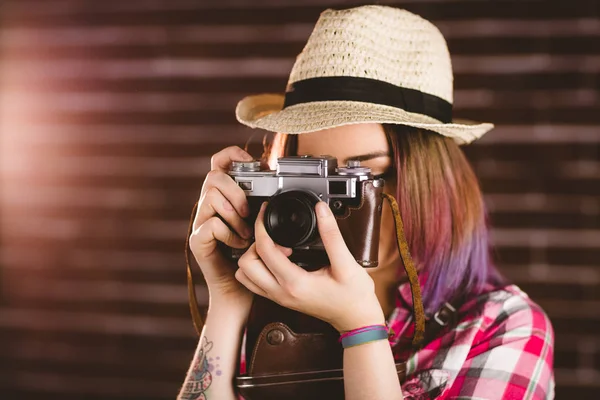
[265,190,319,247]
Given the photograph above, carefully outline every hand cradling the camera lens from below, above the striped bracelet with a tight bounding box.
[235,201,385,332]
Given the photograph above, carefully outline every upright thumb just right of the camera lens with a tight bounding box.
[315,201,356,269]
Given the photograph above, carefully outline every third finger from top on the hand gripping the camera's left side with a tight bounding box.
[197,187,252,239]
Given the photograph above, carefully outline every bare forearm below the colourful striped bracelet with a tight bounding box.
[344,340,403,400]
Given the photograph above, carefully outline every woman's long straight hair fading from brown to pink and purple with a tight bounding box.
[264,124,504,313]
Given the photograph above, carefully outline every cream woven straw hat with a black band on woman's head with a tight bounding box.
[236,5,494,144]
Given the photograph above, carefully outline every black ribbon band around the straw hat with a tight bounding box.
[283,76,452,123]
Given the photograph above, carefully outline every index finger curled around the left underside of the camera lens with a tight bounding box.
[254,203,306,284]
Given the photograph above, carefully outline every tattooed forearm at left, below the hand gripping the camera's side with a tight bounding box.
[178,296,248,400]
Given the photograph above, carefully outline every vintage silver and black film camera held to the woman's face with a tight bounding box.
[228,156,384,270]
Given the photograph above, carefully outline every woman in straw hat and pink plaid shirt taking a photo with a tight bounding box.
[180,6,554,399]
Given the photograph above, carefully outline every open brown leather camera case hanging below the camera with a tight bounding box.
[236,298,406,400]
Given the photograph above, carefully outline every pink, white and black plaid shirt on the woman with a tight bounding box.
[240,283,554,400]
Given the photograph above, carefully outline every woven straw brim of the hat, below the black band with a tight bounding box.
[235,93,494,144]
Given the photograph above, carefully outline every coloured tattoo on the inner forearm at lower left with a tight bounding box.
[180,337,221,400]
